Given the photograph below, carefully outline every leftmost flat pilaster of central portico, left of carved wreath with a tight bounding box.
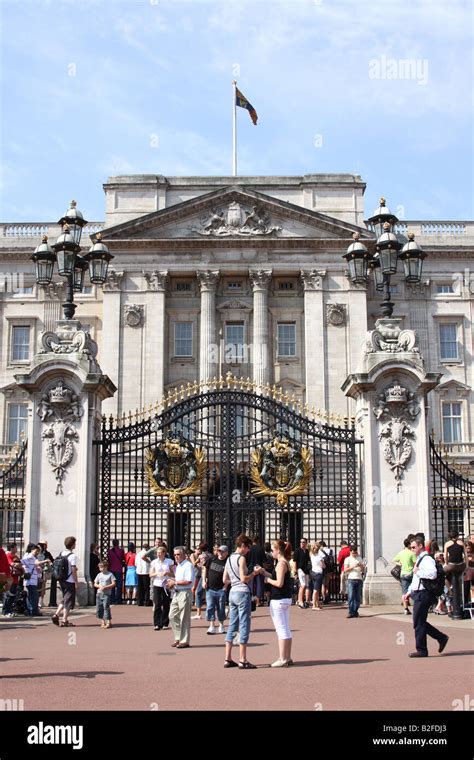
[100,267,124,416]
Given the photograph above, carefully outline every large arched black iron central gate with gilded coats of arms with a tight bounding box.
[96,382,362,554]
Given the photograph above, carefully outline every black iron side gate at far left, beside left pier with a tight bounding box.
[0,441,27,552]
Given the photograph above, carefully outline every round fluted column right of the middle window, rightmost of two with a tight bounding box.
[249,269,272,392]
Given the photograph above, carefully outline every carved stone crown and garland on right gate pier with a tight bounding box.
[374,380,420,491]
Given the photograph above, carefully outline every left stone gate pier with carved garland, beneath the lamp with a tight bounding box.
[15,320,117,604]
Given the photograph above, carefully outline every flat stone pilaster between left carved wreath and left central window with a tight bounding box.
[143,271,168,407]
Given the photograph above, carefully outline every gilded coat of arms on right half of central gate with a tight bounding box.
[250,433,313,507]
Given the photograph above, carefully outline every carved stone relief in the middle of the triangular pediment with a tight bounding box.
[191,201,281,237]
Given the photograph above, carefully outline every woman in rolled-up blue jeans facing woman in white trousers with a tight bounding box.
[224,533,262,670]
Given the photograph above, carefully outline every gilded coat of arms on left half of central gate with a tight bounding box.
[145,434,206,506]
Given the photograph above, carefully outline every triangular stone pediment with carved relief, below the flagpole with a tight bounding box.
[102,186,372,242]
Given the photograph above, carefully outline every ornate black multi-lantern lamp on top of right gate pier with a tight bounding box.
[344,198,426,317]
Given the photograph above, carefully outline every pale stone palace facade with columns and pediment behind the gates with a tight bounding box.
[0,174,474,564]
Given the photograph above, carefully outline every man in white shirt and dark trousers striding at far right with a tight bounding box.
[403,533,449,657]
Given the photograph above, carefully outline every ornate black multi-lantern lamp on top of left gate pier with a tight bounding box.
[31,201,113,319]
